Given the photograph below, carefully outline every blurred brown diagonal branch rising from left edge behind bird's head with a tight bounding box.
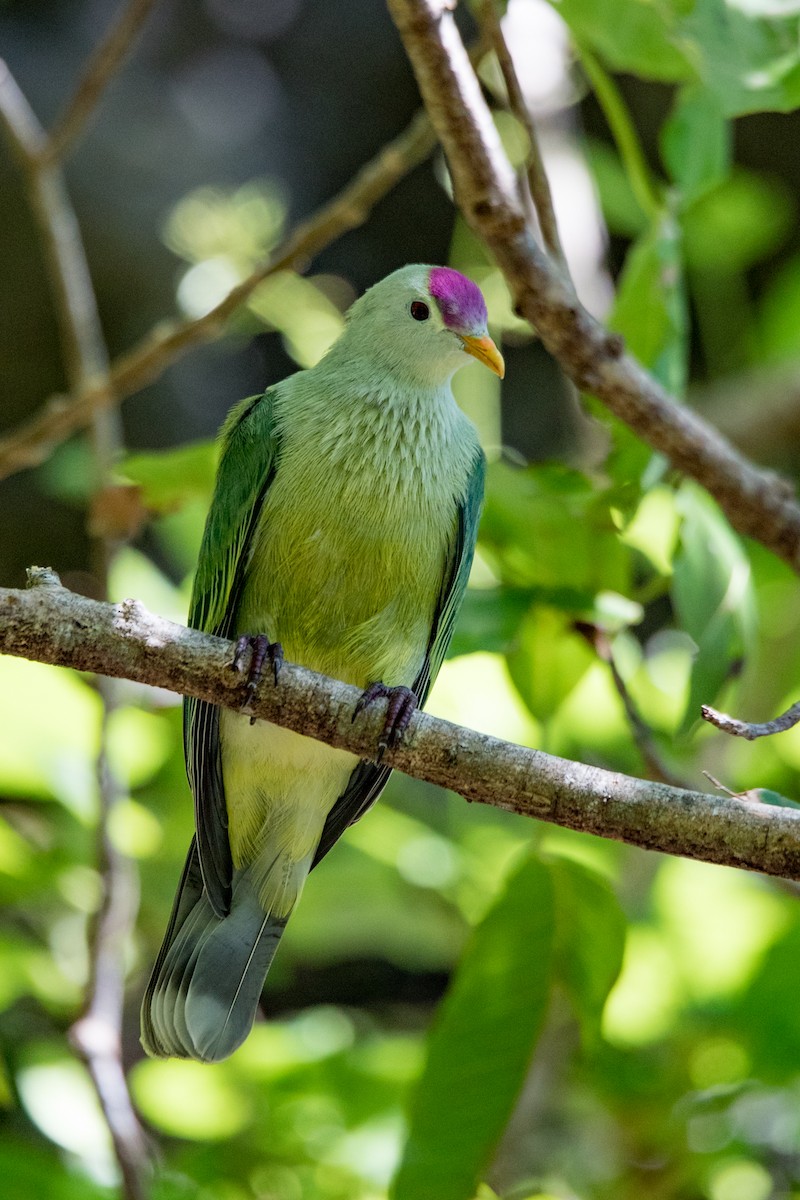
[0,112,437,479]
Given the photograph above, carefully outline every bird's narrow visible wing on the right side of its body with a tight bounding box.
[312,450,486,868]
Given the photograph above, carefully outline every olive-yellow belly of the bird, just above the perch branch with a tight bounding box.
[237,451,457,686]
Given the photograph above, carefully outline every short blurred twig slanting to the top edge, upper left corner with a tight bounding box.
[40,0,156,166]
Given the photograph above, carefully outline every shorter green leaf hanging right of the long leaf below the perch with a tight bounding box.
[551,858,627,1045]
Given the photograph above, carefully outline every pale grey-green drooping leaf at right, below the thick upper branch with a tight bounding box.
[672,482,756,736]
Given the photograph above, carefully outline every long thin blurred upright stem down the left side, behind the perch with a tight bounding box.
[0,56,149,1200]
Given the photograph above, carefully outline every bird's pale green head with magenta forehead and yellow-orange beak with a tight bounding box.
[331,264,505,386]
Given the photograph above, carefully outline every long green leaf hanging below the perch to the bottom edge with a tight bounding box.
[391,858,553,1200]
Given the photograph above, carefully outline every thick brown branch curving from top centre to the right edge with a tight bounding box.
[387,0,800,570]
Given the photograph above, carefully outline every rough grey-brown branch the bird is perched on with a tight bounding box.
[0,568,800,880]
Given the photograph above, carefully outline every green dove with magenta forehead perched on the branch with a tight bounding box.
[142,264,505,1062]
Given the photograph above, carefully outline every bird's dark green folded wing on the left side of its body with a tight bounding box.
[184,389,278,917]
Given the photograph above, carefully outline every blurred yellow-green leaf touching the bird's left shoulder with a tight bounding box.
[118,442,218,512]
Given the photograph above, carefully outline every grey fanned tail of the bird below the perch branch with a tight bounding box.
[142,840,287,1062]
